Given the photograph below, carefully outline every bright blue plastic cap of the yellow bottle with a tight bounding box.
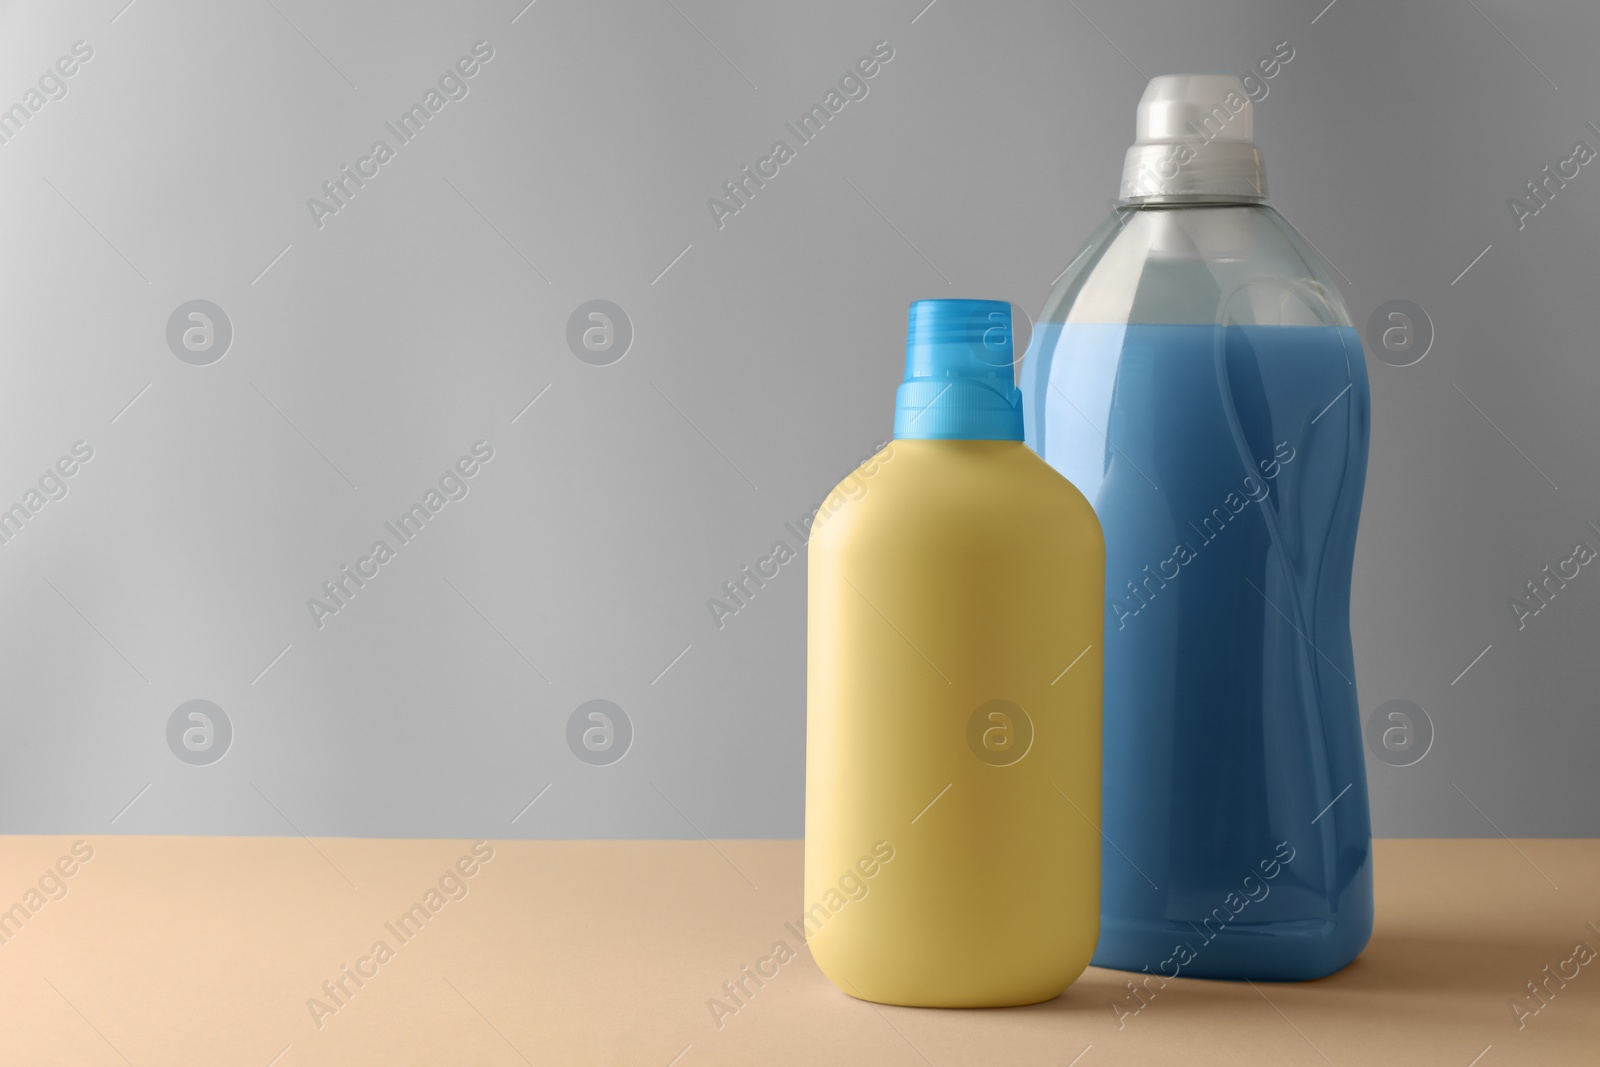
[894,301,1022,442]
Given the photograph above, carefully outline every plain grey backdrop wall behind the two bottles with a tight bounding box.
[0,0,1600,837]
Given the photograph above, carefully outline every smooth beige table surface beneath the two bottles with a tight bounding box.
[0,837,1600,1067]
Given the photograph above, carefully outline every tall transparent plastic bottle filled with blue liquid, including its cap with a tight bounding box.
[1021,75,1373,979]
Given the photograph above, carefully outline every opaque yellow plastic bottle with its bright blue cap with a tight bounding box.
[802,301,1106,1008]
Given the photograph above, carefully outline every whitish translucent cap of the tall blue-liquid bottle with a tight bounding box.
[1122,74,1267,203]
